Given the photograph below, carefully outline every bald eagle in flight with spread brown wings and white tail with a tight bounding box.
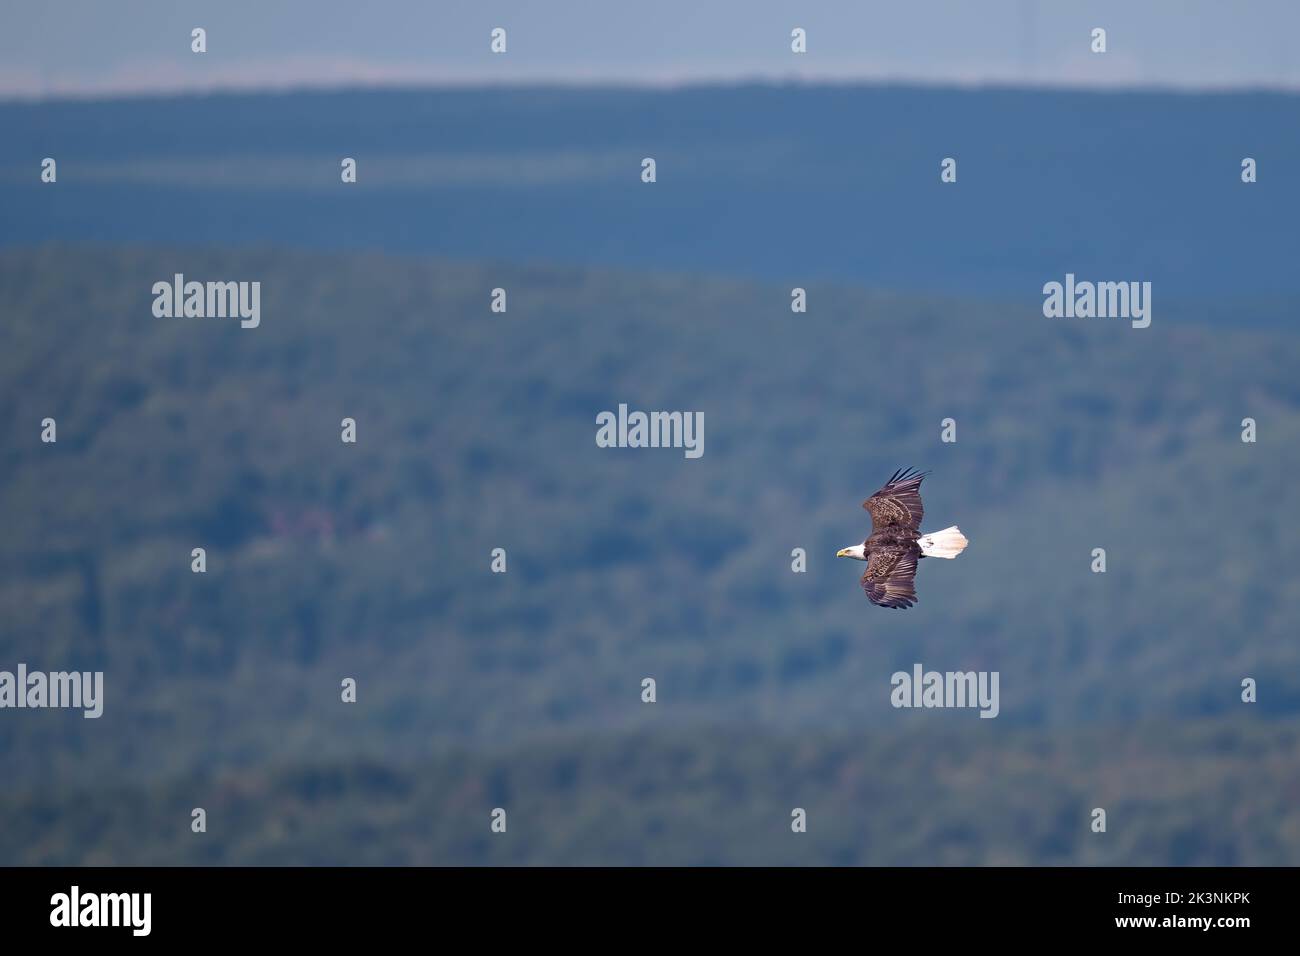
[835,468,967,609]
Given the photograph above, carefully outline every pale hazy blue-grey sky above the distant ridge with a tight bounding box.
[0,0,1300,96]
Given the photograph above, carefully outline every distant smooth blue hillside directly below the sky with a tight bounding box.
[0,83,1300,312]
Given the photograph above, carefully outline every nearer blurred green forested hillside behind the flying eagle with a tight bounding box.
[0,245,1300,864]
